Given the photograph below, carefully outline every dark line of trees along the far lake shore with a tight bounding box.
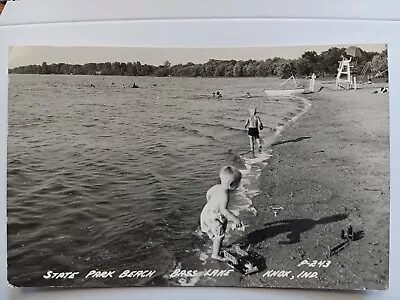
[9,47,387,78]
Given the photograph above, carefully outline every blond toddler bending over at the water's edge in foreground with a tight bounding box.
[200,166,243,260]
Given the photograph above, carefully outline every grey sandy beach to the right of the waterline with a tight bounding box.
[231,84,389,290]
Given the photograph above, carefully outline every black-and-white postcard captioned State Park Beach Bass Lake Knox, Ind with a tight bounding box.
[7,44,390,290]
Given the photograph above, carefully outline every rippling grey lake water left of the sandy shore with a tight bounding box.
[7,75,303,286]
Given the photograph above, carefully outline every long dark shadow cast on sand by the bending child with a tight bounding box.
[236,214,348,247]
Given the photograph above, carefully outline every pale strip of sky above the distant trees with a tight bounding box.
[8,44,386,68]
